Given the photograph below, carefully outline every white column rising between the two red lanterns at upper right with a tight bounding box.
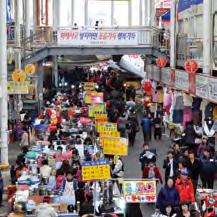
[170,0,176,68]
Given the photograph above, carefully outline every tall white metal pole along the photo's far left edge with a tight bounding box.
[0,0,8,164]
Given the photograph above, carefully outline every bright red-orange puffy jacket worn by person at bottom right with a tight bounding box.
[176,178,195,203]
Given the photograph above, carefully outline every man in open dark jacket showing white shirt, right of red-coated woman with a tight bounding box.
[163,151,177,182]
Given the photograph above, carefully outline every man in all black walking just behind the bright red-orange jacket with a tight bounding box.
[187,152,200,193]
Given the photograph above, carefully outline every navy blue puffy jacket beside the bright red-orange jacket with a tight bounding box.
[157,185,180,210]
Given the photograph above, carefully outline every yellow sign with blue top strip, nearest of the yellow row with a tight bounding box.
[81,160,111,181]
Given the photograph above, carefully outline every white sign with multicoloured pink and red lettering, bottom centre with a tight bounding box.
[123,180,157,203]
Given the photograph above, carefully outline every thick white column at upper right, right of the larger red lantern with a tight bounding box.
[203,0,212,75]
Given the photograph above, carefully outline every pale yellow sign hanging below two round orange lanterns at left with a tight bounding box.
[8,81,29,94]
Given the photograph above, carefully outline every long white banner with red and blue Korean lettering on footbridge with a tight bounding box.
[57,30,139,46]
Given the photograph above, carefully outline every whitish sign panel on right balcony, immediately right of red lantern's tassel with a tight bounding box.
[196,75,209,99]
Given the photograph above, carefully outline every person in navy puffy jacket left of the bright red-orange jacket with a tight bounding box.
[156,177,180,213]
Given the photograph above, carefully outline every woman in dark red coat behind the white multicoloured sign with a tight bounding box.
[142,161,163,184]
